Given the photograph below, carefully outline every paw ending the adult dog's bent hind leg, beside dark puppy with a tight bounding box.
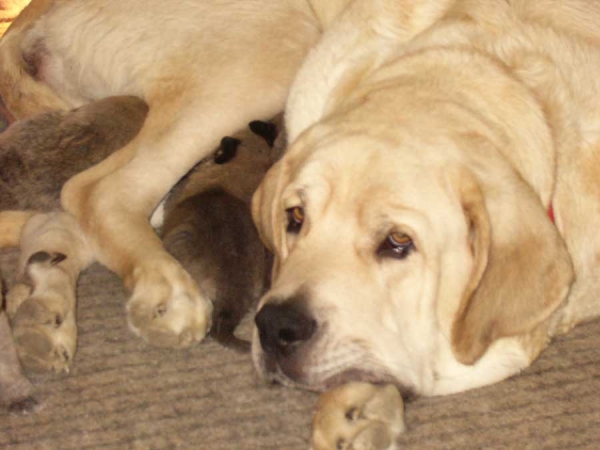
[127,260,212,347]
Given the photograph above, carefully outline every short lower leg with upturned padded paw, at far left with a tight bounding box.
[7,213,92,372]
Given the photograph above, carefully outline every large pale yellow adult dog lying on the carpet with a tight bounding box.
[0,0,600,448]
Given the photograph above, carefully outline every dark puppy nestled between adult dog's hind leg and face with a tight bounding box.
[163,117,284,352]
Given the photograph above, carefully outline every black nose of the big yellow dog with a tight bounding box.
[254,301,317,356]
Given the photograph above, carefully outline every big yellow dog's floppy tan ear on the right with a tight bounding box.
[452,172,573,364]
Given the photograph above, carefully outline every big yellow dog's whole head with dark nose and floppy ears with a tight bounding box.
[253,94,572,393]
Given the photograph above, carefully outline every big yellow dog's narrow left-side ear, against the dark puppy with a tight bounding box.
[252,160,289,276]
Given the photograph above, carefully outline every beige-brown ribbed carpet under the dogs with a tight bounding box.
[0,248,600,450]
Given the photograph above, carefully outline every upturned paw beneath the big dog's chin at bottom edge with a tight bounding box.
[312,383,404,450]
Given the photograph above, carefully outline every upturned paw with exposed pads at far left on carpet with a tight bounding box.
[7,252,77,373]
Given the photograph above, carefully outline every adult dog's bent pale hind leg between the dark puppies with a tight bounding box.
[62,92,283,347]
